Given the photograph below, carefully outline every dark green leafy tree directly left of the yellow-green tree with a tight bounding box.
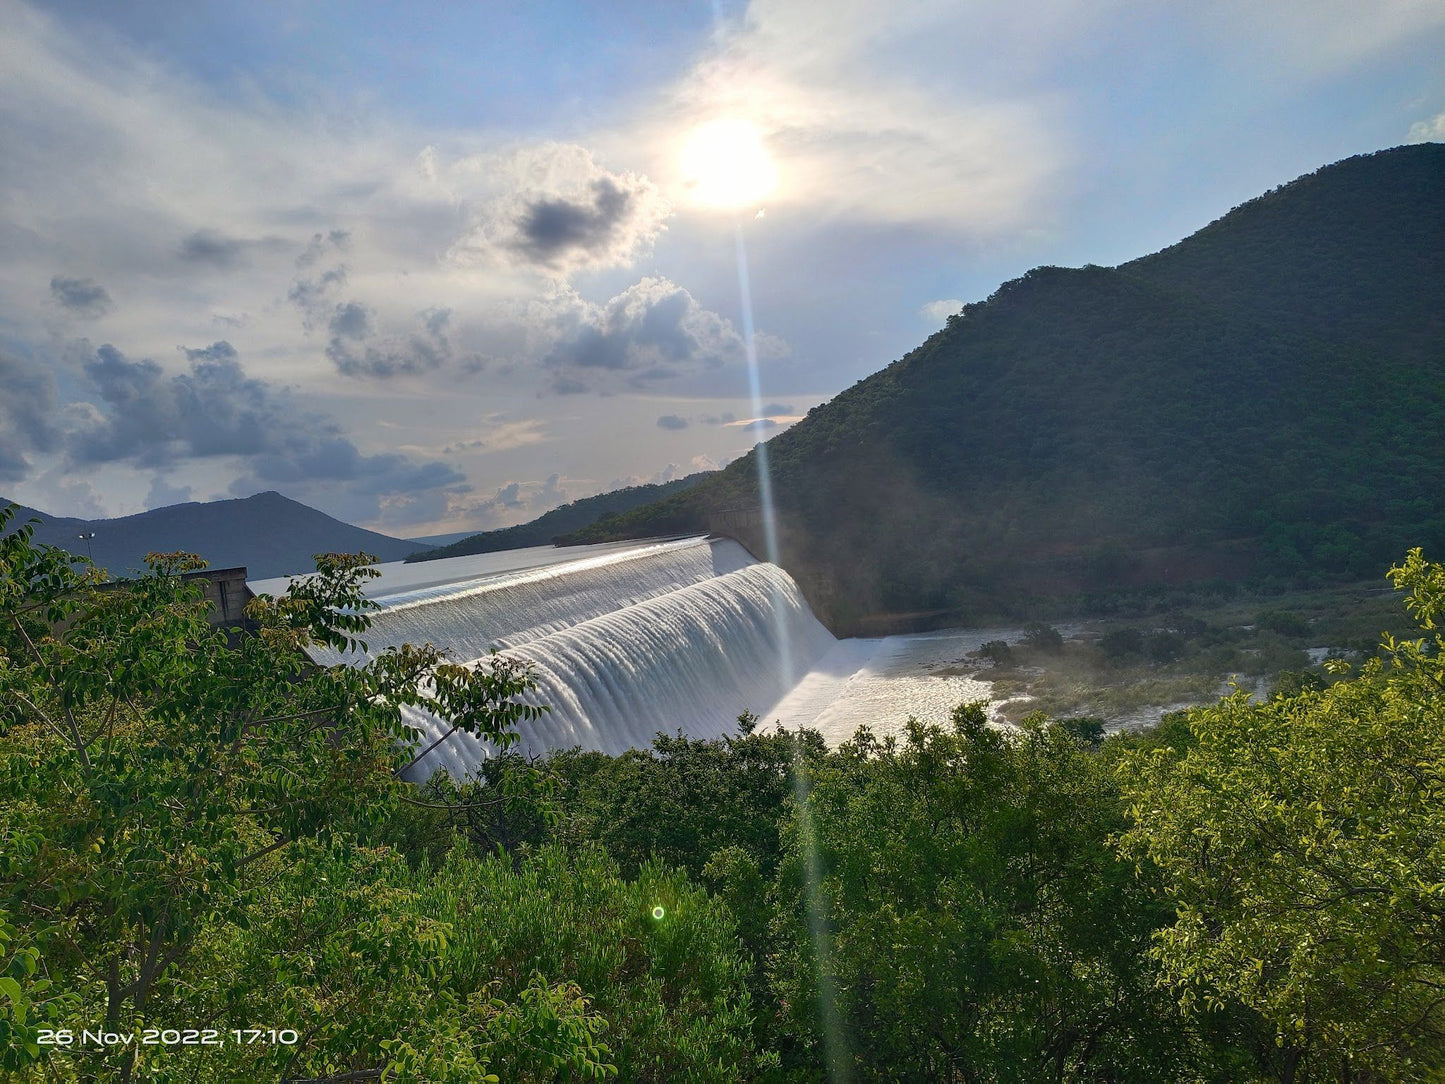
[772,704,1227,1081]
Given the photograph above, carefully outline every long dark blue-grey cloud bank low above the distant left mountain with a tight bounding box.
[66,343,465,517]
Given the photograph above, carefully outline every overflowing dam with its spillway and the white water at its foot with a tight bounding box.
[250,536,1006,778]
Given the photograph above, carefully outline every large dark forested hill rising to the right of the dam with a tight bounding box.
[560,143,1445,629]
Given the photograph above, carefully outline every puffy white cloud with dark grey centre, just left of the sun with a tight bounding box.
[449,143,672,278]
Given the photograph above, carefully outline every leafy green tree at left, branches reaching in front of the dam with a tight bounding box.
[0,507,539,1080]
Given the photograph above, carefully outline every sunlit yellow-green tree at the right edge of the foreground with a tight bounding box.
[1123,549,1445,1080]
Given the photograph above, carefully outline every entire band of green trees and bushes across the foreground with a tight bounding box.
[0,505,1445,1084]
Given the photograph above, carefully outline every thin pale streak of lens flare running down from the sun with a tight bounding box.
[734,218,853,1080]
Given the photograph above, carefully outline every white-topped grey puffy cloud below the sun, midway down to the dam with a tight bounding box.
[543,278,762,393]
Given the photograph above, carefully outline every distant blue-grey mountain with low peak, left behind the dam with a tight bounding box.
[0,493,419,580]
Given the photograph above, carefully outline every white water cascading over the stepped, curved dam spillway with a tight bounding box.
[296,539,835,778]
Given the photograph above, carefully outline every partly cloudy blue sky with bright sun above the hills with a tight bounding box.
[8,0,1445,536]
